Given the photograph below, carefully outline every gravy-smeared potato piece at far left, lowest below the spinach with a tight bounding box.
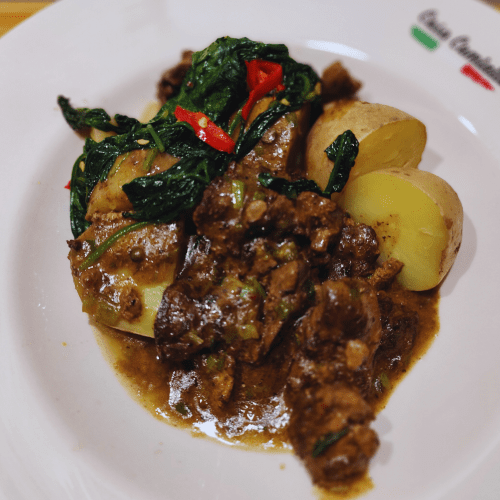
[68,212,184,337]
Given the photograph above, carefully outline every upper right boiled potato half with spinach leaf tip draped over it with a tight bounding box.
[306,100,427,193]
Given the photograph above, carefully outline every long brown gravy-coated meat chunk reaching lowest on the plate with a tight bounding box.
[287,278,382,487]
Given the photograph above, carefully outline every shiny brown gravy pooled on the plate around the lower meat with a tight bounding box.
[91,288,439,500]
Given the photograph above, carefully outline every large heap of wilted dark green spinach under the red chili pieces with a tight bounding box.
[58,37,320,238]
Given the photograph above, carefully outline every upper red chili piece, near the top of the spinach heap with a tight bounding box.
[241,59,285,120]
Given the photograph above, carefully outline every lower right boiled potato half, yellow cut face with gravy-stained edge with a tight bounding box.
[339,168,463,290]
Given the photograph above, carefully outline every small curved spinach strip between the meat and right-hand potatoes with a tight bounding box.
[259,130,359,199]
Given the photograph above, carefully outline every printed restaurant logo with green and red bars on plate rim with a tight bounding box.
[410,9,500,90]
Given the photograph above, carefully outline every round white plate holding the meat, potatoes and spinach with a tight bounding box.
[0,0,500,500]
